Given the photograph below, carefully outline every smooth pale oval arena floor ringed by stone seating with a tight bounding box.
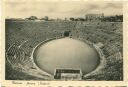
[33,37,100,75]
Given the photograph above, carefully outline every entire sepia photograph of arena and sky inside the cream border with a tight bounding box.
[4,0,124,81]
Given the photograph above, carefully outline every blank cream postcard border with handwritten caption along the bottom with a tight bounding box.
[0,0,128,87]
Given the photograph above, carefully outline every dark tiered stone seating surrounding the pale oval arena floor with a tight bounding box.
[5,21,123,81]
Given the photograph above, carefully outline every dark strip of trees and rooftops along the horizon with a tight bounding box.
[6,15,123,22]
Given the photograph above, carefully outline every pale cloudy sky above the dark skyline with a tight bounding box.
[5,0,122,18]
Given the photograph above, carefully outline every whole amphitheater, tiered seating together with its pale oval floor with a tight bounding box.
[5,21,122,81]
